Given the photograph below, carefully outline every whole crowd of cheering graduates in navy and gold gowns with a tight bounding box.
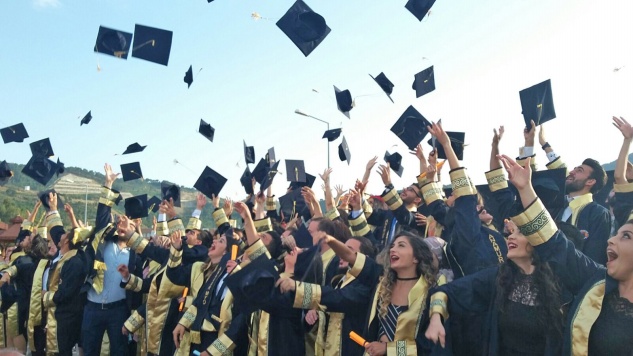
[0,117,633,356]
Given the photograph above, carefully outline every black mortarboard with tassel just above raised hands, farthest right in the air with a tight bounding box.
[519,79,556,127]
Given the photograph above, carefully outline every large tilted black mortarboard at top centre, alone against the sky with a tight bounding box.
[277,0,330,57]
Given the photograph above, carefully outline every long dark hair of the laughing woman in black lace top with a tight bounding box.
[495,253,563,336]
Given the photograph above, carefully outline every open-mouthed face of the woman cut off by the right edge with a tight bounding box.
[607,224,633,281]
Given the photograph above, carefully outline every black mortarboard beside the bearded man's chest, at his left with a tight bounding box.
[532,168,567,216]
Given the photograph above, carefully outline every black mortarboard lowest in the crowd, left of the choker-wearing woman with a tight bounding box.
[224,255,279,315]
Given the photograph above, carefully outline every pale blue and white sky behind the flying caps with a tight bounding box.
[0,0,633,199]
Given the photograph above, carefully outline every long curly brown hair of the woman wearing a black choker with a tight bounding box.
[378,232,438,318]
